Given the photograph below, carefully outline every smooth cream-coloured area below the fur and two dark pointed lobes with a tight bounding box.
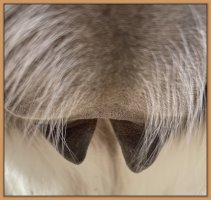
[5,119,207,195]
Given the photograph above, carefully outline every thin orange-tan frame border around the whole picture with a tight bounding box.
[0,0,211,200]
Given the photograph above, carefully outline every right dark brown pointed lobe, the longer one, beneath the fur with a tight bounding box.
[111,120,160,172]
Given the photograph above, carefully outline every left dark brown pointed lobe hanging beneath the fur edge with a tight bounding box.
[40,119,97,164]
